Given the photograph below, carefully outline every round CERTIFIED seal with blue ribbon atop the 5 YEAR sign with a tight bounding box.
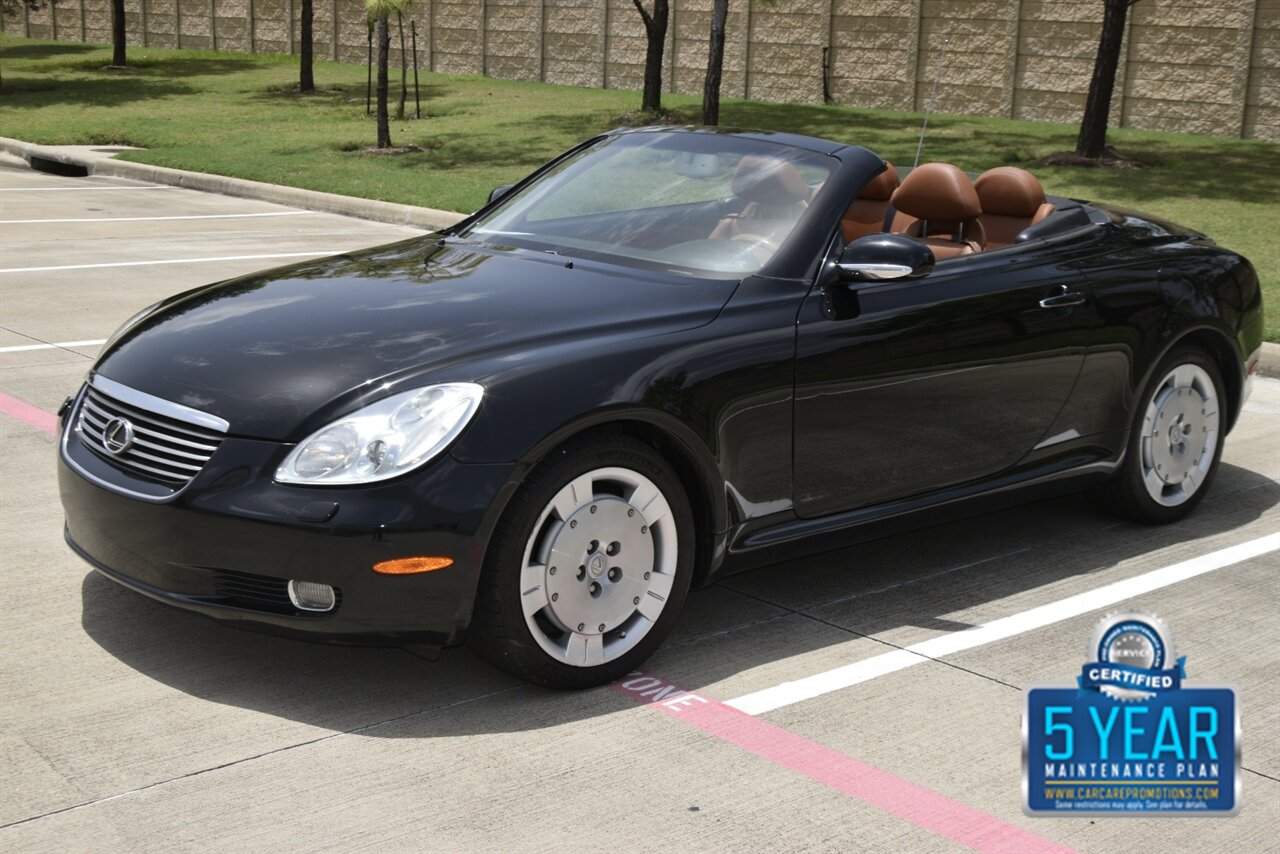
[1079,611,1187,700]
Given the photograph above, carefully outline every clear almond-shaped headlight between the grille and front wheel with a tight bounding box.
[275,383,484,485]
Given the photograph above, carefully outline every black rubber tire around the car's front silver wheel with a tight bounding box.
[467,435,695,688]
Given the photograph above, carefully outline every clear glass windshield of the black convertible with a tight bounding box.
[463,132,835,275]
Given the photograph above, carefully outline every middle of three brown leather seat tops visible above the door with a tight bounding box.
[892,163,987,261]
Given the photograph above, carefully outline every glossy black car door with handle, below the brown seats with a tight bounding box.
[794,243,1097,517]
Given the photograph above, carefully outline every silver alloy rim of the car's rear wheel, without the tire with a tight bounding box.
[1140,362,1219,507]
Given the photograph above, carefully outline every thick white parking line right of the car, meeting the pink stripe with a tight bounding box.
[724,534,1280,714]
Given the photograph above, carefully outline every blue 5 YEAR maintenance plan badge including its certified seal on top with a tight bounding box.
[1023,612,1240,816]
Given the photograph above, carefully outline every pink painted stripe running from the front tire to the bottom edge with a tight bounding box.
[613,671,1073,854]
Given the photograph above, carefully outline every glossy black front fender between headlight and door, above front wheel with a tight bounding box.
[452,279,803,560]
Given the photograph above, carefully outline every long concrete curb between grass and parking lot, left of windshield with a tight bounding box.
[0,137,466,230]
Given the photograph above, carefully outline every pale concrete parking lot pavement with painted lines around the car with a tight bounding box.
[0,155,1280,851]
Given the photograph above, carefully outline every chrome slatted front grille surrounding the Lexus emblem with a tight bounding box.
[76,385,225,487]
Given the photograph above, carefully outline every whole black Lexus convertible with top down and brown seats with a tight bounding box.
[59,128,1262,686]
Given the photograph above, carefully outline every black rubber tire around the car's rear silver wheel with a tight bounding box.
[1094,347,1228,525]
